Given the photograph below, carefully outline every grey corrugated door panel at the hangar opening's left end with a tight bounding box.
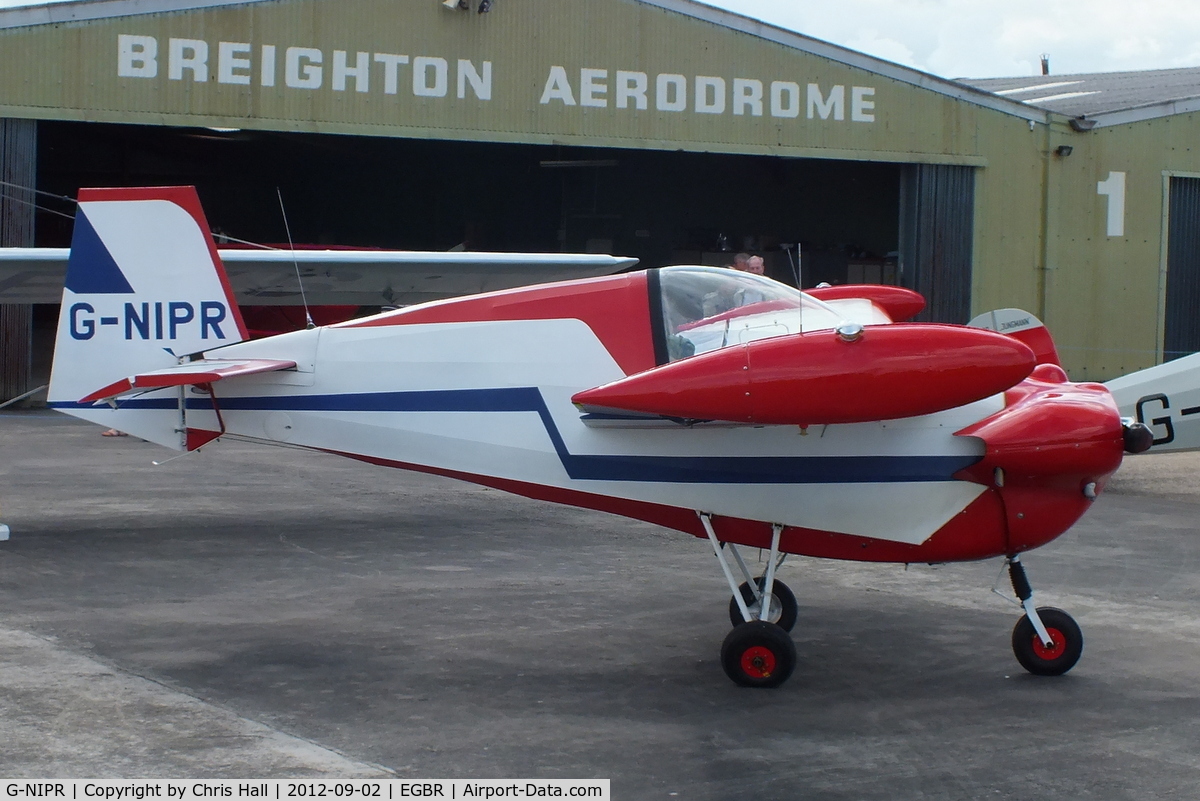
[0,120,37,401]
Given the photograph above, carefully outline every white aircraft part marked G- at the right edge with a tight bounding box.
[1105,354,1200,453]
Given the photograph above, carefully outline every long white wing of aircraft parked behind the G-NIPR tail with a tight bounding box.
[0,247,637,306]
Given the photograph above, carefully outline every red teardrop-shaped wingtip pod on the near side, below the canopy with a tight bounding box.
[572,325,1034,426]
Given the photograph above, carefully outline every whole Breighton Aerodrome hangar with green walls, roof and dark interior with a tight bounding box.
[0,0,1200,397]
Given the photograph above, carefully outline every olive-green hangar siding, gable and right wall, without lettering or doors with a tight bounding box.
[0,0,1200,379]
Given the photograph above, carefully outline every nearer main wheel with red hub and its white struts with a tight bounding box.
[697,512,796,687]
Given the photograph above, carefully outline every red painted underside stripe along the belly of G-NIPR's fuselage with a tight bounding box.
[320,448,1022,564]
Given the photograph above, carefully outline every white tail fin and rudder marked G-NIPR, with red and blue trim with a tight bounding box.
[49,186,247,450]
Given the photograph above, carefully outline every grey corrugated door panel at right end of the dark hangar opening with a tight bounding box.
[900,164,974,323]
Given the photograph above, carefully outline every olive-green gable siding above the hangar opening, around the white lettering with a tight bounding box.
[0,0,1017,164]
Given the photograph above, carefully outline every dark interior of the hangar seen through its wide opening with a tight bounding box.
[36,121,901,285]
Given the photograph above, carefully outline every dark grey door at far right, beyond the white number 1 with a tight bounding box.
[1163,176,1200,361]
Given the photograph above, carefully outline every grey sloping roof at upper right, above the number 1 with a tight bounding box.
[962,67,1200,125]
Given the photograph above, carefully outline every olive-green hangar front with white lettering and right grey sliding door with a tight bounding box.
[0,0,1200,388]
